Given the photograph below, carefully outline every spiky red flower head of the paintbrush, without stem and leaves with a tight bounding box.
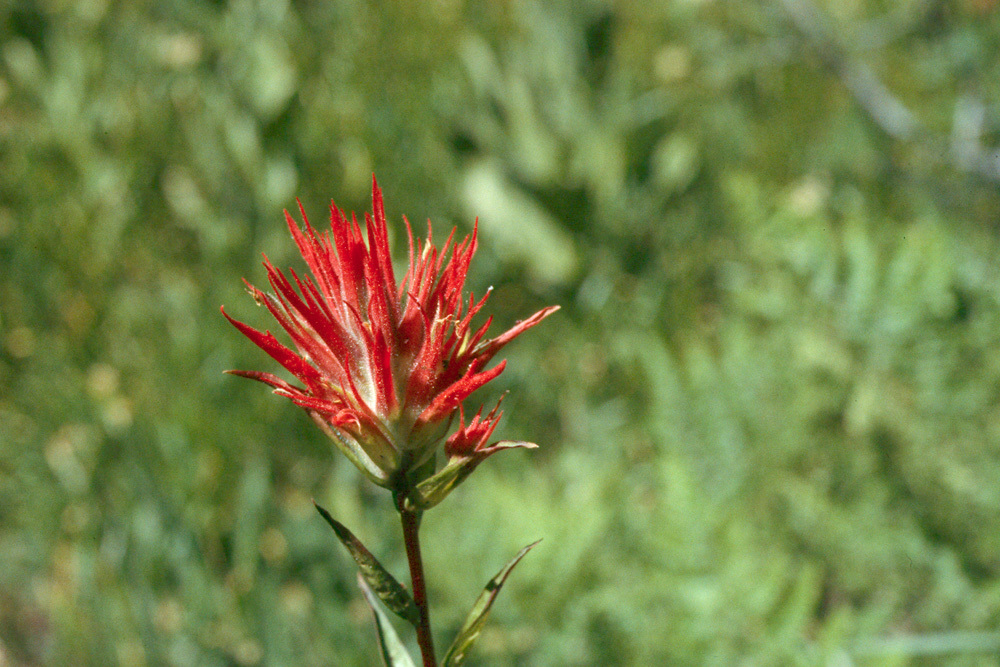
[223,179,558,487]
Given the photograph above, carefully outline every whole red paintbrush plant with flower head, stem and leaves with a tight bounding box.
[222,179,558,667]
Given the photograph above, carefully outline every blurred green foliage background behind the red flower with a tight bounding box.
[0,0,1000,667]
